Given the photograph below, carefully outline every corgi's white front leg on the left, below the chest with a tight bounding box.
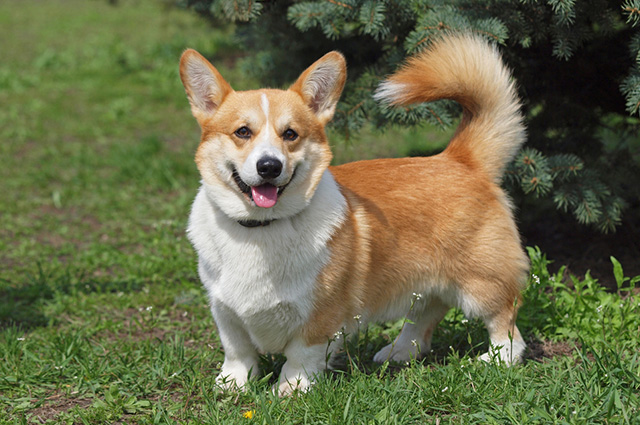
[211,306,259,390]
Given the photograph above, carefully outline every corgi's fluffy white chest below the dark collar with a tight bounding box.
[188,173,346,351]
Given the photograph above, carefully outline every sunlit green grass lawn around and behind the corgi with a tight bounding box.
[0,0,640,424]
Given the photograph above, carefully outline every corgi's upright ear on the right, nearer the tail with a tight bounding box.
[289,52,347,124]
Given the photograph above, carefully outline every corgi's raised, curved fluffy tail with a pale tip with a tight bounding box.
[374,34,526,182]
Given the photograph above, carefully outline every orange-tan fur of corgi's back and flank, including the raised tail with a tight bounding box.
[298,36,528,352]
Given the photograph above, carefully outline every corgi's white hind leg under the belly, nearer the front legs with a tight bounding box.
[373,298,449,363]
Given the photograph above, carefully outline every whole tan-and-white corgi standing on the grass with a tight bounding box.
[180,34,529,395]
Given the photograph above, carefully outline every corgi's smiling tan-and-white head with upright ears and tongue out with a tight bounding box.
[180,50,346,220]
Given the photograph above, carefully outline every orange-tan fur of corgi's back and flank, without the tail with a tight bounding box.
[307,151,528,338]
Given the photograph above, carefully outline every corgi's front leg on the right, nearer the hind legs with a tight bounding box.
[278,337,327,396]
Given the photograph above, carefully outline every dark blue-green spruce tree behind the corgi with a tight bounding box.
[176,0,640,232]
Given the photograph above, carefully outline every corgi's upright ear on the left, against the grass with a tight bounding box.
[180,49,233,123]
